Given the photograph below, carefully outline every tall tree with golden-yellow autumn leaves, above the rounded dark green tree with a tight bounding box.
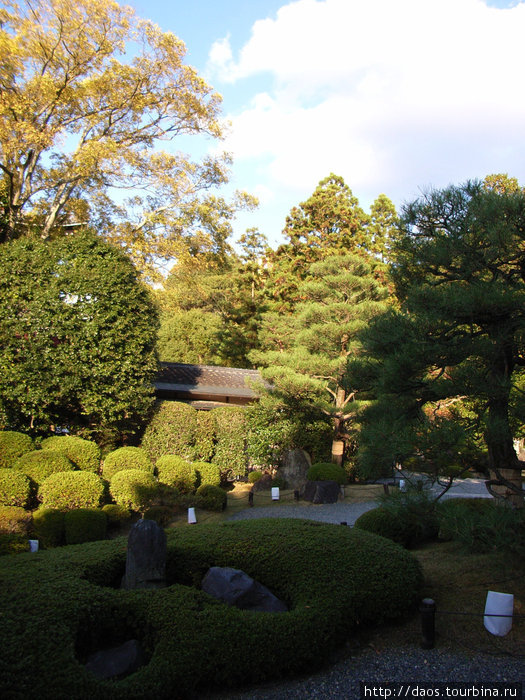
[0,0,254,278]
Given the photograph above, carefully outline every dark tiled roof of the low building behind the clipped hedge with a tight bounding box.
[155,362,261,399]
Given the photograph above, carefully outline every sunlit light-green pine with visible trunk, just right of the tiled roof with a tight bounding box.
[251,254,387,464]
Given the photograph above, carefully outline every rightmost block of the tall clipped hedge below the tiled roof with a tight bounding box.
[212,406,248,476]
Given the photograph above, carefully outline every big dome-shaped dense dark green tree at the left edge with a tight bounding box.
[0,233,157,436]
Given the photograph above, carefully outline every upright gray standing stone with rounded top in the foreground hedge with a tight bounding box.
[122,520,166,590]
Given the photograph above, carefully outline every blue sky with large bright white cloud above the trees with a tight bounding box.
[127,0,525,247]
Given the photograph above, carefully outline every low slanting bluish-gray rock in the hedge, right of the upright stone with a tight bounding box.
[202,566,288,612]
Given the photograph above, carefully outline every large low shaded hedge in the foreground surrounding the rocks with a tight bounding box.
[0,519,422,700]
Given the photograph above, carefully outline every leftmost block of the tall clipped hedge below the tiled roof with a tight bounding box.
[142,401,197,462]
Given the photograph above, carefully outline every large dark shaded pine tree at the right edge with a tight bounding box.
[356,182,525,503]
